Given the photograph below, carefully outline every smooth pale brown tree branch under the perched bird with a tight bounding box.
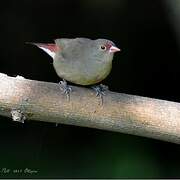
[0,73,180,143]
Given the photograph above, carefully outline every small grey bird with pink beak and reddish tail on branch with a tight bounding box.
[28,37,121,100]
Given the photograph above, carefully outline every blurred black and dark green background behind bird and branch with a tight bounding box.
[0,0,180,178]
